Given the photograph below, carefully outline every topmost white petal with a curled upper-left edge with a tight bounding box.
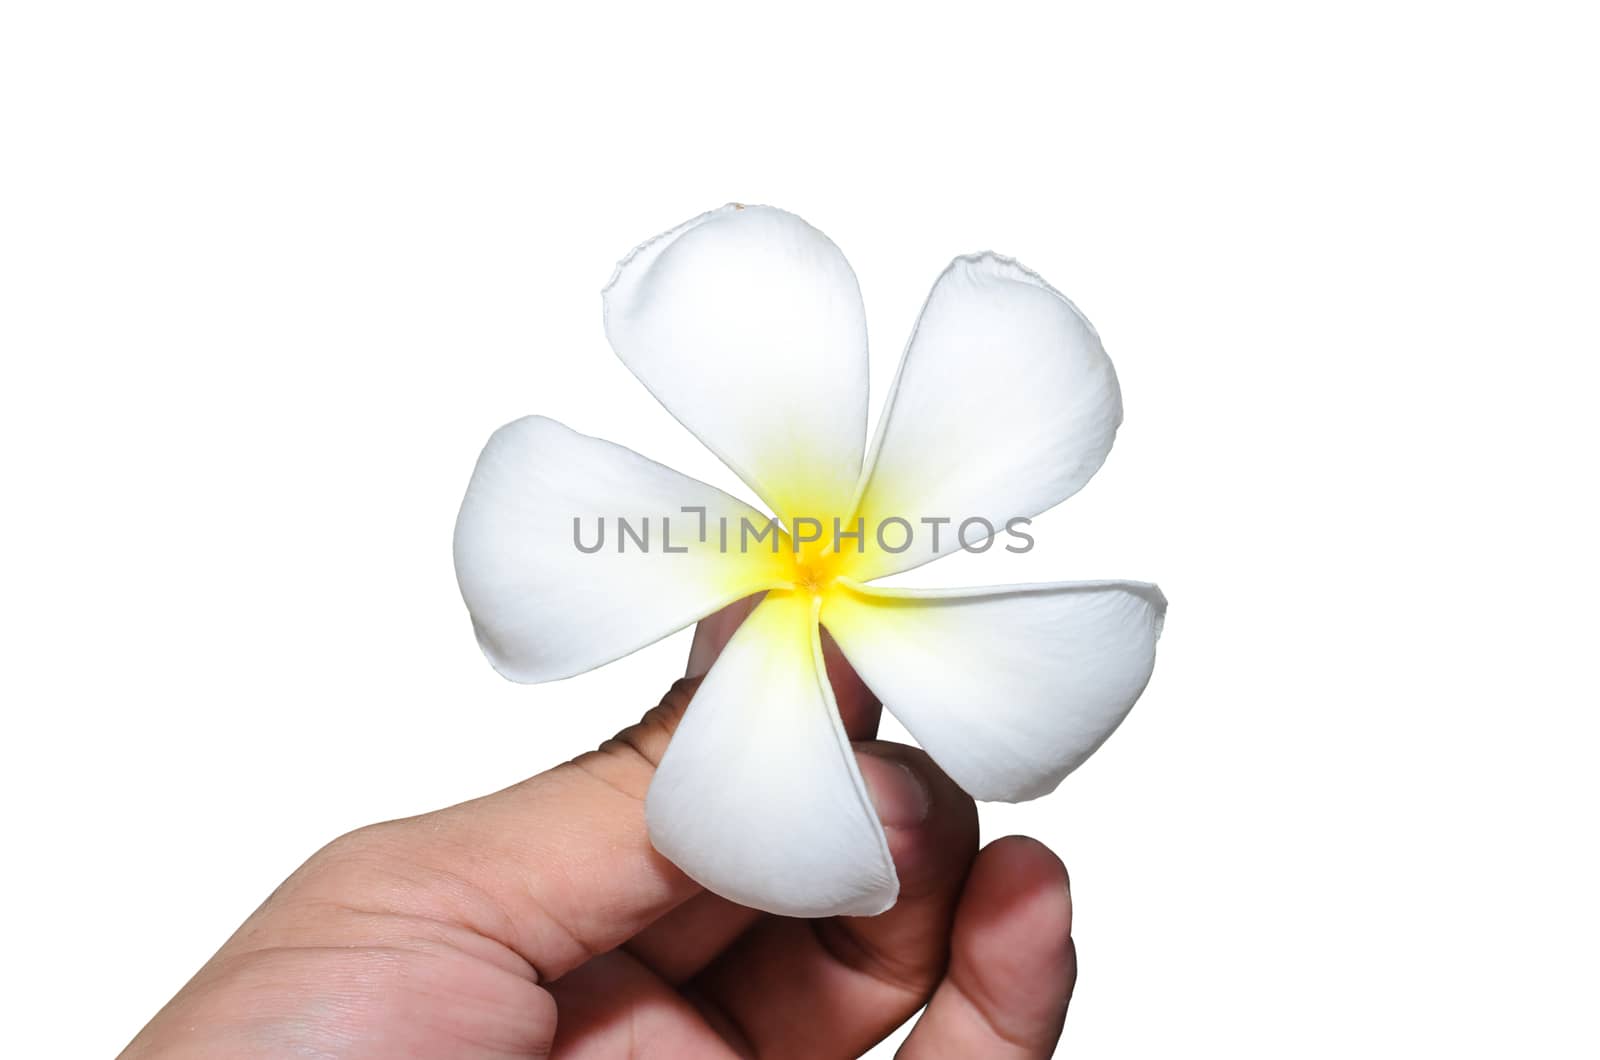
[605,205,867,519]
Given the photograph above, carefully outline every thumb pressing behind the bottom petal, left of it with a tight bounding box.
[292,679,701,982]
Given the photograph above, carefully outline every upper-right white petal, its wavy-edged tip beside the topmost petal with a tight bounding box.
[851,255,1122,580]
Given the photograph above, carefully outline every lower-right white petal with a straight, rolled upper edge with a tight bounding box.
[822,581,1166,802]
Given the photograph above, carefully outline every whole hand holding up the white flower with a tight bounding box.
[122,602,1077,1060]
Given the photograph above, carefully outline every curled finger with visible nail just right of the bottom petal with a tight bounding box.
[686,743,978,1057]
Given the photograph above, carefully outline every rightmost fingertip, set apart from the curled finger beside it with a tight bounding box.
[899,836,1078,1060]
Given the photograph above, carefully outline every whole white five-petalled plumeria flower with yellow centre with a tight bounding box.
[454,205,1166,916]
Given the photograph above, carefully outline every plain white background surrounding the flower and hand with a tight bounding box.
[0,2,1600,1057]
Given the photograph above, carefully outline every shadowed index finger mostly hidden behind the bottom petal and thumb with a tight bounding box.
[627,624,882,983]
